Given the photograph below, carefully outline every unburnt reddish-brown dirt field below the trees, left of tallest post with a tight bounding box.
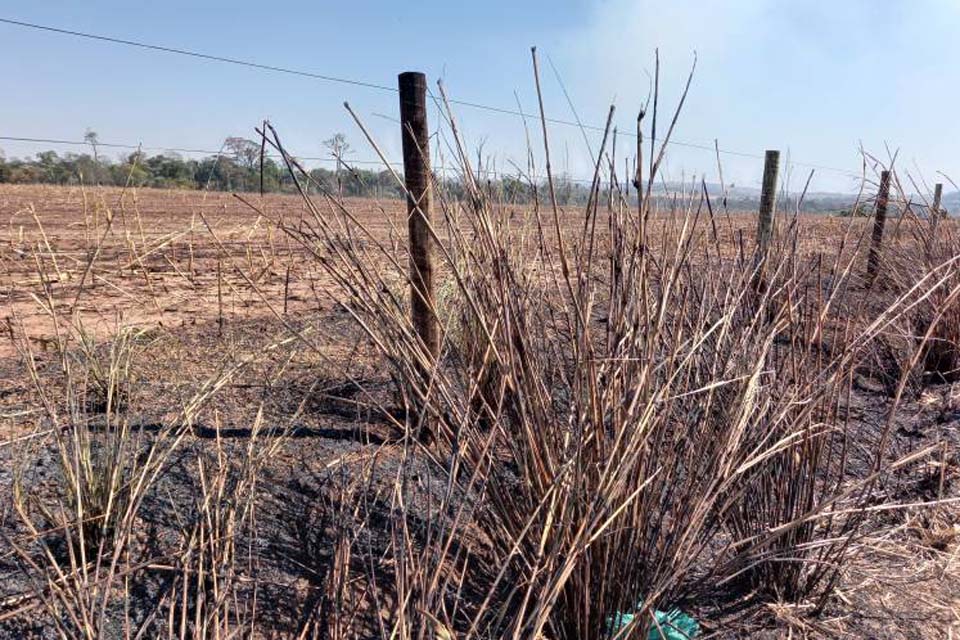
[0,186,403,355]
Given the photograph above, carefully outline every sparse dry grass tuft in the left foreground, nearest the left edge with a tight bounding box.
[10,324,171,638]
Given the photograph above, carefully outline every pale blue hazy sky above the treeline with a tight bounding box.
[0,0,960,190]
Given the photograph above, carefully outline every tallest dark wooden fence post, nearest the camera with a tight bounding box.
[398,71,440,435]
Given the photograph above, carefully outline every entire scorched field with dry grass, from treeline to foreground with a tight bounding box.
[0,186,960,640]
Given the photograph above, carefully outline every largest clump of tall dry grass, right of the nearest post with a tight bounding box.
[249,58,960,640]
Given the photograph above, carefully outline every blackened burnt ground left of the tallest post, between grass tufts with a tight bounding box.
[0,310,460,638]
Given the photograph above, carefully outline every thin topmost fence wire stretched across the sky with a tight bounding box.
[0,17,862,178]
